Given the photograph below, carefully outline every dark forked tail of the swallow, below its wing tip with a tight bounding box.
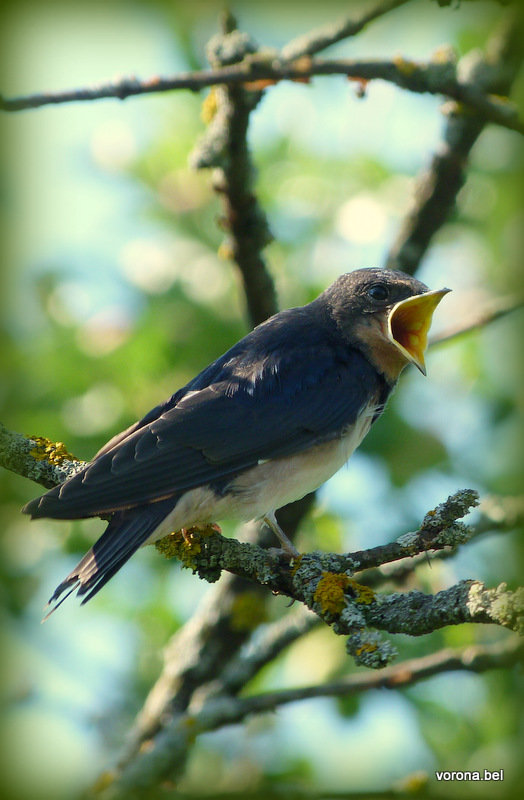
[42,499,173,622]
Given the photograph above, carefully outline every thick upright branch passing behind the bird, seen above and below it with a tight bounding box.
[116,13,286,764]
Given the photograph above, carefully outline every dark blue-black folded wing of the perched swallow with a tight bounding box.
[24,342,380,519]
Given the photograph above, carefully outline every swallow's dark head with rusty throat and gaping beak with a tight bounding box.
[327,268,450,381]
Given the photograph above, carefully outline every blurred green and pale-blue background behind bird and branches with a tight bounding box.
[0,0,524,800]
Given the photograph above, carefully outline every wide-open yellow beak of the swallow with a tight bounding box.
[388,289,451,375]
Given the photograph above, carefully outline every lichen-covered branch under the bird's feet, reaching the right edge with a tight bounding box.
[160,532,521,636]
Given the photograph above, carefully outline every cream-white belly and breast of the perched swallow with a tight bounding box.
[147,405,375,544]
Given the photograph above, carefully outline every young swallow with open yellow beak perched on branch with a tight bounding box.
[22,267,450,616]
